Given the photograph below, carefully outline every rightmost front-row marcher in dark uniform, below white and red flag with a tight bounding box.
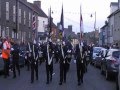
[75,44,85,85]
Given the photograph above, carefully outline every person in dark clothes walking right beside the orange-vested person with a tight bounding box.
[11,42,20,78]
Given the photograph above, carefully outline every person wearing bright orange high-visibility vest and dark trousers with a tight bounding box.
[2,38,11,78]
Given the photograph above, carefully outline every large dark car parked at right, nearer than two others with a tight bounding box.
[101,49,120,80]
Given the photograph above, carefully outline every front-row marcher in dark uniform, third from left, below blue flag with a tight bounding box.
[59,42,67,85]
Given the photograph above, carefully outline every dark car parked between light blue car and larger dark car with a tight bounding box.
[94,48,107,67]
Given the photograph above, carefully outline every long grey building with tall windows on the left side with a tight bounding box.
[0,0,38,42]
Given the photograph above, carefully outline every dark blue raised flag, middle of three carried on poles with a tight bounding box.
[59,5,64,39]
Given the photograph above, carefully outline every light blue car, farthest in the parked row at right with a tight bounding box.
[91,47,102,65]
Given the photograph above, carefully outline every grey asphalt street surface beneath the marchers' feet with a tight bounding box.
[0,62,116,90]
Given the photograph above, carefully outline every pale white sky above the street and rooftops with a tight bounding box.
[27,0,118,33]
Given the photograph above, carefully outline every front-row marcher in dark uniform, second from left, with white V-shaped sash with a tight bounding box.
[46,42,53,84]
